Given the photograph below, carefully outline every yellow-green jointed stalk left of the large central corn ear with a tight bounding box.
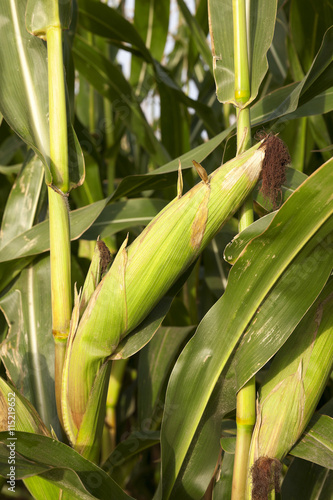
[26,0,72,428]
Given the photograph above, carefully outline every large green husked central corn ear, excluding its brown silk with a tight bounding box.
[62,140,272,460]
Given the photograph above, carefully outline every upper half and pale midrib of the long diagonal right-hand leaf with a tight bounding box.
[158,155,333,498]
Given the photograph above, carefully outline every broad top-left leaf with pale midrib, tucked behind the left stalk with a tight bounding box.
[0,0,84,187]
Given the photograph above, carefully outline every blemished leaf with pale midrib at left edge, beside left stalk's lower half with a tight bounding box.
[0,257,60,432]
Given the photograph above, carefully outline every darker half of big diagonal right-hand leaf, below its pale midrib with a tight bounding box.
[166,218,333,498]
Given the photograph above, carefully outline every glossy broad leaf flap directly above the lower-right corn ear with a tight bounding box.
[229,225,333,390]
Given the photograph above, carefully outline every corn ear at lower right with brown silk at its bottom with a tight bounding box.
[246,280,333,500]
